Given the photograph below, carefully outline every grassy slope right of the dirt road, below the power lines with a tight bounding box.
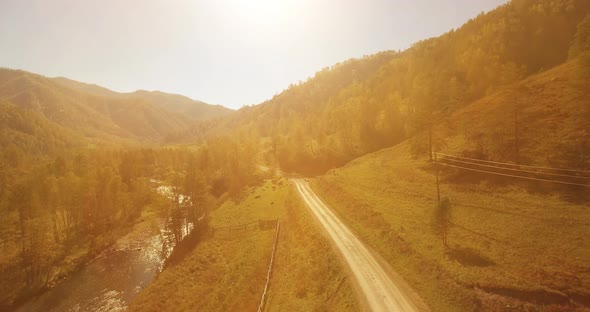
[312,145,590,311]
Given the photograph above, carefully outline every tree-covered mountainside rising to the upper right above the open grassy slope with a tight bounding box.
[188,0,590,172]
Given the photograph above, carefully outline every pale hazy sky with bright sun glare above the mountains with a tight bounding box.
[0,0,507,108]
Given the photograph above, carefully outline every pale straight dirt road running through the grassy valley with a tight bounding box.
[292,179,428,311]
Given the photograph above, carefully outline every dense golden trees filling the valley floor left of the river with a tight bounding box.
[0,136,259,309]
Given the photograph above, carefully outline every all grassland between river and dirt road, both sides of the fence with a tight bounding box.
[129,179,357,311]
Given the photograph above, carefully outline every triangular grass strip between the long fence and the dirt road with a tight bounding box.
[267,183,359,311]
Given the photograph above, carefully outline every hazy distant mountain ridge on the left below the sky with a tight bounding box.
[0,69,232,155]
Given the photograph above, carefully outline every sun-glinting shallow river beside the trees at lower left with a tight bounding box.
[16,184,192,312]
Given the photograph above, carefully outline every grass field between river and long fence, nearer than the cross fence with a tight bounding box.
[129,232,272,311]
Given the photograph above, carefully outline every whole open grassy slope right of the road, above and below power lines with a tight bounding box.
[312,60,590,311]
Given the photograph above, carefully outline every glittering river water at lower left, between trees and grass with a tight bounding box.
[11,209,164,311]
